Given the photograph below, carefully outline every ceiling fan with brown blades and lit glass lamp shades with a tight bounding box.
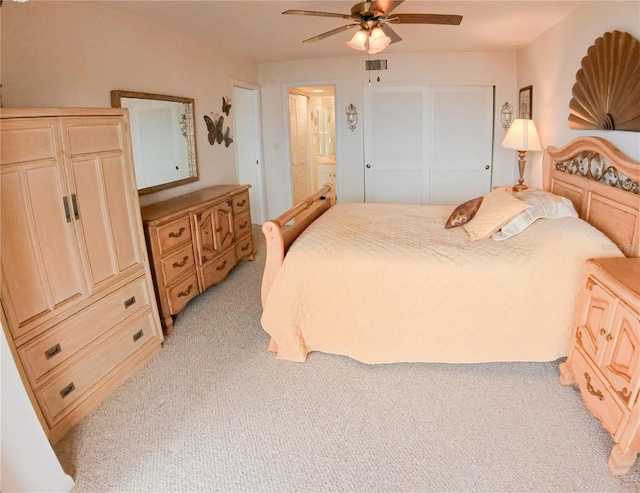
[283,0,462,54]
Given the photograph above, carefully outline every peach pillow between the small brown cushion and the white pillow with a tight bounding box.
[462,188,530,241]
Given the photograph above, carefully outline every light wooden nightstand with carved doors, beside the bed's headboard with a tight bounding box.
[560,258,640,475]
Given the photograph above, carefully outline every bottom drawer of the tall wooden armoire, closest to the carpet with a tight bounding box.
[36,310,158,426]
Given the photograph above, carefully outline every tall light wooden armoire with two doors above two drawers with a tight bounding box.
[0,108,162,442]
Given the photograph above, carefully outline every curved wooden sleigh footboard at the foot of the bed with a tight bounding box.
[261,183,336,308]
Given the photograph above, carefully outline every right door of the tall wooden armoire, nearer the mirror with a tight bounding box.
[62,117,143,292]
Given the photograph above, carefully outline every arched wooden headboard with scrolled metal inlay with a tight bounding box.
[542,137,640,257]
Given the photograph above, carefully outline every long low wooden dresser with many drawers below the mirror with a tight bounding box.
[142,185,255,334]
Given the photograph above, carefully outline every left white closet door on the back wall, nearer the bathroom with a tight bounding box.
[363,86,430,204]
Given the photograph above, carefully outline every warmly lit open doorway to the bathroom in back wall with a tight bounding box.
[288,85,336,205]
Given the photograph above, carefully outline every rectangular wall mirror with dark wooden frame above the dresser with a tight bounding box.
[111,91,198,194]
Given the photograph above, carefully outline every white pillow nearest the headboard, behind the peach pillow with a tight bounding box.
[492,190,578,241]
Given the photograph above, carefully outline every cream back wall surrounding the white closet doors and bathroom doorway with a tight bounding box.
[260,53,517,217]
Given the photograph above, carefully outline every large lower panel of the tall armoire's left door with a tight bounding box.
[0,161,85,337]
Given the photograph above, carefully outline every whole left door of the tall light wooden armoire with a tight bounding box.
[0,118,87,337]
